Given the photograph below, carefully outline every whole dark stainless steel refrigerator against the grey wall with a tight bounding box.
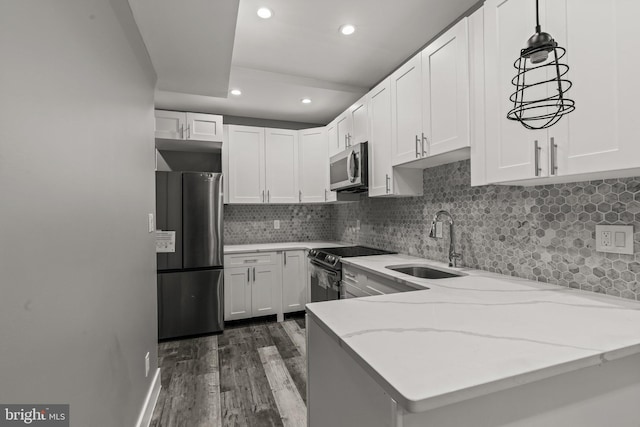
[156,172,224,339]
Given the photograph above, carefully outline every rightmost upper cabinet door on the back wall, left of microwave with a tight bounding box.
[298,127,329,203]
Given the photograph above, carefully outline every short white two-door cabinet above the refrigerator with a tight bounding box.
[155,110,222,142]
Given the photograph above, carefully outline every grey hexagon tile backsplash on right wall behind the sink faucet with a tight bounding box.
[331,160,640,299]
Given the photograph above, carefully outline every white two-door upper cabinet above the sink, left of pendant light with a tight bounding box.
[391,18,470,167]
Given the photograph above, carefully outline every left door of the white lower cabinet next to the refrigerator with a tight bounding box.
[224,267,253,320]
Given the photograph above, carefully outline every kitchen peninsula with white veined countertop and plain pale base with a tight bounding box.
[307,255,640,427]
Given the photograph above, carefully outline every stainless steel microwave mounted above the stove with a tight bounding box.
[329,142,369,193]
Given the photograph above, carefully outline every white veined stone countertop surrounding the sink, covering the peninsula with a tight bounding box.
[307,255,640,412]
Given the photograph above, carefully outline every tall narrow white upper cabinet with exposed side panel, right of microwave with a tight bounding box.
[368,78,422,197]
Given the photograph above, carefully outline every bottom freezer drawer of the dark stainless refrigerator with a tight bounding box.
[158,269,224,339]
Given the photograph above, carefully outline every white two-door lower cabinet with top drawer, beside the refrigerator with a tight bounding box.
[224,252,282,321]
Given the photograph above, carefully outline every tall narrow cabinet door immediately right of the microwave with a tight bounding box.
[369,78,392,197]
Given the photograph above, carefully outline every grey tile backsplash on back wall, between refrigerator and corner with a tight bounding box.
[224,205,333,245]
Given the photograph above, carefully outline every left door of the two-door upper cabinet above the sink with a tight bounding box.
[391,54,422,166]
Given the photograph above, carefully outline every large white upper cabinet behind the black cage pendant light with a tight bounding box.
[484,0,640,185]
